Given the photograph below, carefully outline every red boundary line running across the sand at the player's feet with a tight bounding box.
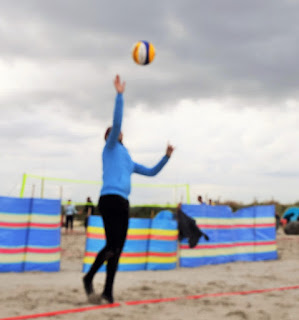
[0,285,299,320]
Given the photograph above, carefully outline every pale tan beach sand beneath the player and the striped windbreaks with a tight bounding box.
[0,226,299,320]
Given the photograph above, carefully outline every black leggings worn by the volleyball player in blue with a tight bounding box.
[86,195,129,297]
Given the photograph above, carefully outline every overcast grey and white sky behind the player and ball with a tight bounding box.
[0,0,299,203]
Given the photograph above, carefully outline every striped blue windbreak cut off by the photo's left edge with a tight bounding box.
[0,197,61,272]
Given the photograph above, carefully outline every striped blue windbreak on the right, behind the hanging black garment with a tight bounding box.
[180,205,277,267]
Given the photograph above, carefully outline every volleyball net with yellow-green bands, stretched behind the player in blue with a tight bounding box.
[19,173,190,207]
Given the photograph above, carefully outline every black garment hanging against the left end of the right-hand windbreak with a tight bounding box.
[177,209,209,248]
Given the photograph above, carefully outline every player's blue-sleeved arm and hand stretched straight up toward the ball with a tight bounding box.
[107,75,126,147]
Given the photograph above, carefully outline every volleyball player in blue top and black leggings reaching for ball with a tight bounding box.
[83,75,174,303]
